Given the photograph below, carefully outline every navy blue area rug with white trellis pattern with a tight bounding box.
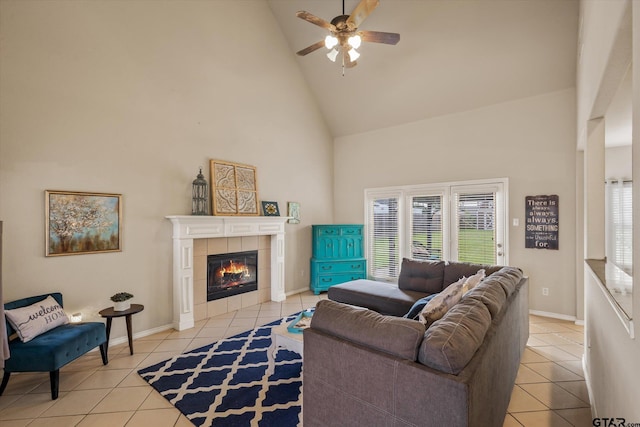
[138,315,302,427]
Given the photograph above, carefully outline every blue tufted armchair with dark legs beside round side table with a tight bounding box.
[0,292,109,400]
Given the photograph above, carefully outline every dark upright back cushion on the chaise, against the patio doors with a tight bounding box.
[398,258,442,294]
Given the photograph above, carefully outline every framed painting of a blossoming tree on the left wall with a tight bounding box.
[44,190,122,256]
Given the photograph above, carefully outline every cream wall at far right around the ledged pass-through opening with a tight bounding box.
[577,0,640,423]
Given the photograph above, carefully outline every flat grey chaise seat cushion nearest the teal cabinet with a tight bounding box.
[328,279,425,316]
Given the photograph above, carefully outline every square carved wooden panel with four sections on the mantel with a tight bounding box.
[211,160,259,215]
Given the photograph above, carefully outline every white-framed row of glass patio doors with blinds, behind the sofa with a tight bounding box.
[365,179,507,281]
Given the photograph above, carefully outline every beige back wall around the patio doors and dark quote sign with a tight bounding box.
[334,89,576,316]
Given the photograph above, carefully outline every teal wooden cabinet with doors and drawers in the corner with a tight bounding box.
[311,224,367,295]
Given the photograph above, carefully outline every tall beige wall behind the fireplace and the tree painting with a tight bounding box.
[0,0,333,337]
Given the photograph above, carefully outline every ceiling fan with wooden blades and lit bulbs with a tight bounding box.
[296,0,400,70]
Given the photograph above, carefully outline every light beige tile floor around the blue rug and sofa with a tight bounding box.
[0,292,591,427]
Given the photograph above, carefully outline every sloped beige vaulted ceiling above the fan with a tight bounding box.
[267,0,579,137]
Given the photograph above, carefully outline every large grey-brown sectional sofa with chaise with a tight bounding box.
[303,260,529,427]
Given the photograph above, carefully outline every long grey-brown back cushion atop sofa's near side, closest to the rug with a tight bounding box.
[311,300,425,362]
